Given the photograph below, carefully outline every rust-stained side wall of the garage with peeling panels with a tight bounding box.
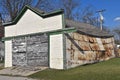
[65,33,115,68]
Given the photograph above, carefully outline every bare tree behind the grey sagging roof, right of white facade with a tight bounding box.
[61,0,99,26]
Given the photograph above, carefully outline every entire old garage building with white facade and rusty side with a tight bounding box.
[2,6,114,69]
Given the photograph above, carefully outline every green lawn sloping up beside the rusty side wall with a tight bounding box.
[29,58,120,80]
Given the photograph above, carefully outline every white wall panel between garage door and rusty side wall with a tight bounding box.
[49,34,63,69]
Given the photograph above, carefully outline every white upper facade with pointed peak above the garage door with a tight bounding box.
[5,10,62,37]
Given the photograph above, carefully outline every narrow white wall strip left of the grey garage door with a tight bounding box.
[5,41,12,67]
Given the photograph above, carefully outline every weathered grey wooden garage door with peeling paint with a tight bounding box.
[12,34,48,66]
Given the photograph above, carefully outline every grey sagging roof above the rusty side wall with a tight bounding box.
[66,19,113,37]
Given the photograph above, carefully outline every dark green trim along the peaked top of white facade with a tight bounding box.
[3,5,64,26]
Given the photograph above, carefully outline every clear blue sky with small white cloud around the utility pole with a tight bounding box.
[81,0,120,28]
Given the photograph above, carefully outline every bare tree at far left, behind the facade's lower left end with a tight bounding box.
[1,0,31,20]
